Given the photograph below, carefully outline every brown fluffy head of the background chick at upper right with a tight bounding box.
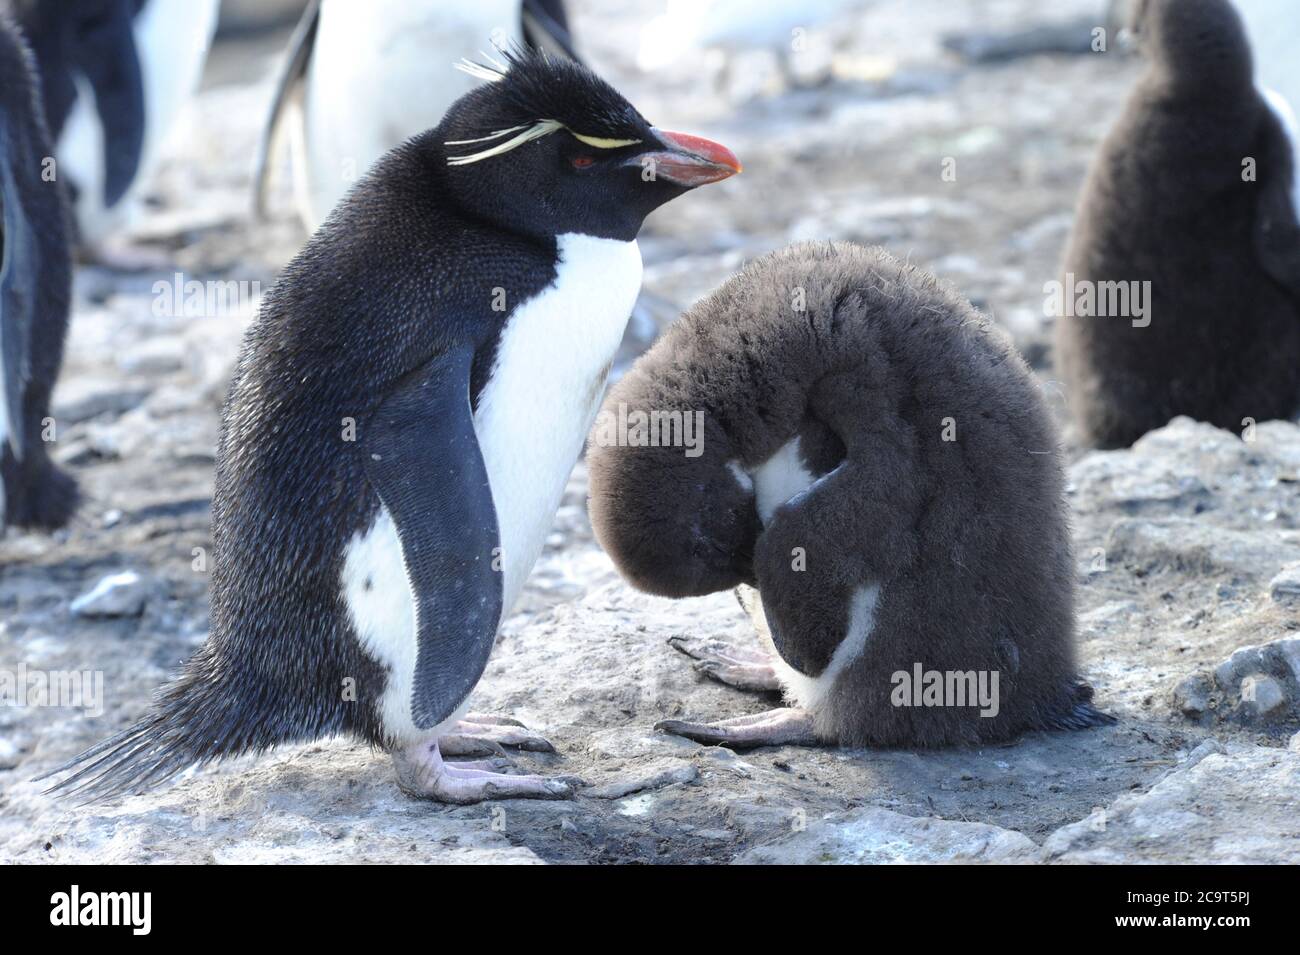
[1130,0,1253,91]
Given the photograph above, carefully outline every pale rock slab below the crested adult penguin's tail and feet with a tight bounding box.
[13,742,543,864]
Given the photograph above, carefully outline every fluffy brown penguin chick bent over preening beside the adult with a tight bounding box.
[588,243,1110,747]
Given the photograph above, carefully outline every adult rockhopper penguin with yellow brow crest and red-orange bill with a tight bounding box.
[45,53,740,802]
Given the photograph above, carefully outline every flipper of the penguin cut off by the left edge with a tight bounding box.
[0,125,39,459]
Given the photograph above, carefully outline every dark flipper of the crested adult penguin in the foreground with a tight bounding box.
[361,347,503,729]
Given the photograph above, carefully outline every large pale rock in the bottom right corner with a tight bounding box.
[1043,746,1300,865]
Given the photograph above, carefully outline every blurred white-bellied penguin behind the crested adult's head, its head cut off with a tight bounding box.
[254,0,576,231]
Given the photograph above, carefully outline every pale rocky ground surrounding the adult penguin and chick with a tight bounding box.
[0,0,1300,863]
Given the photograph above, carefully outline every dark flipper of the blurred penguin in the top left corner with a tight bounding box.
[73,0,144,205]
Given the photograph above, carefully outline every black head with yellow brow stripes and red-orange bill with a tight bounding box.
[434,52,740,240]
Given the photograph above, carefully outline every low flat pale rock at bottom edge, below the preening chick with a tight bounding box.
[735,807,1039,865]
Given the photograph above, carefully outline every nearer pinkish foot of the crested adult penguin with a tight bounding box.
[393,739,579,806]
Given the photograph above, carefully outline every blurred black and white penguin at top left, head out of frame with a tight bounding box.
[12,0,220,247]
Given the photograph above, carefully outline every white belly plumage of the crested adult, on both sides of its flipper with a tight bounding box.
[341,235,641,743]
